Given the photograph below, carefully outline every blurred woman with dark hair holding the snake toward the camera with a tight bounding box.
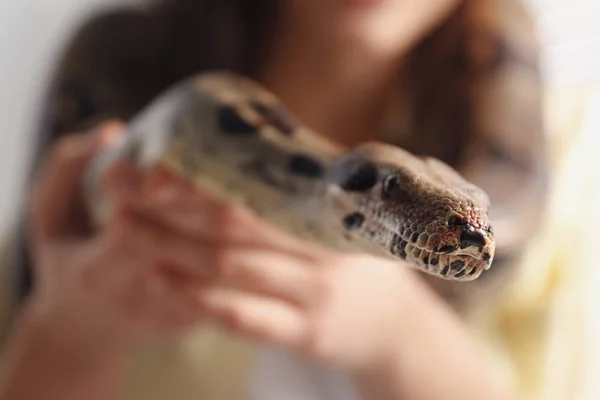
[0,0,544,400]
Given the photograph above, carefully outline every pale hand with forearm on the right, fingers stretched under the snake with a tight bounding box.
[139,191,511,400]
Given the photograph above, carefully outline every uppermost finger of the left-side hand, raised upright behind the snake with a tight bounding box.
[32,123,125,238]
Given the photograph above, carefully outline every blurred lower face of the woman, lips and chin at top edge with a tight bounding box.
[284,0,460,55]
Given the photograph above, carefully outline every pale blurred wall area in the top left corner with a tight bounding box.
[0,0,122,234]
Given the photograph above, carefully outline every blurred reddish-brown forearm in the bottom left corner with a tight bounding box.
[0,304,130,400]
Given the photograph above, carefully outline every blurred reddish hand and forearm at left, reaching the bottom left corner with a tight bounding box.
[0,123,225,400]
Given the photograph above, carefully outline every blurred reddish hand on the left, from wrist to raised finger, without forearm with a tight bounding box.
[31,123,206,347]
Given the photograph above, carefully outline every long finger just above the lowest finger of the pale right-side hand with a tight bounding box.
[121,205,323,305]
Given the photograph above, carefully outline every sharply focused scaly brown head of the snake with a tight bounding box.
[332,143,495,281]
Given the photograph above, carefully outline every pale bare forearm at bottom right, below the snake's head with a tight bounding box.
[357,278,516,400]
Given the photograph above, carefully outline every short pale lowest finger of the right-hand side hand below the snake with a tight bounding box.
[197,287,309,348]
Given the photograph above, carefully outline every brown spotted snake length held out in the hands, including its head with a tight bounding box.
[86,71,495,281]
